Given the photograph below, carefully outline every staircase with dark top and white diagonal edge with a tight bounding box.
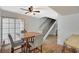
[40,17,56,40]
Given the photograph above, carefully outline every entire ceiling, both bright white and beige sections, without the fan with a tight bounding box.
[0,6,79,19]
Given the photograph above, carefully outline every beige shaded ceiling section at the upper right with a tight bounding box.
[49,6,79,15]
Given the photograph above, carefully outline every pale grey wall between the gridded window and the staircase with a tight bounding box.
[25,16,41,32]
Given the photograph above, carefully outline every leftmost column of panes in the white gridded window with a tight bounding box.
[2,18,9,43]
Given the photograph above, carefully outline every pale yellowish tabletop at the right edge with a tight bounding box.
[65,35,79,49]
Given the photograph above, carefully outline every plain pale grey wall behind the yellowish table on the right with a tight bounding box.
[57,14,79,45]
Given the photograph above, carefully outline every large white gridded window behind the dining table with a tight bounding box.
[2,18,24,44]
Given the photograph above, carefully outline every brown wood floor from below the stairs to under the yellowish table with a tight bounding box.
[43,35,71,53]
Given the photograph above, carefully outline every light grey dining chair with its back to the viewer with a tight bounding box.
[29,35,43,52]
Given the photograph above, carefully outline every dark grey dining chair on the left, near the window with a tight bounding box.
[8,34,25,53]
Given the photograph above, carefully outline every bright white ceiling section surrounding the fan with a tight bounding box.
[1,6,57,19]
